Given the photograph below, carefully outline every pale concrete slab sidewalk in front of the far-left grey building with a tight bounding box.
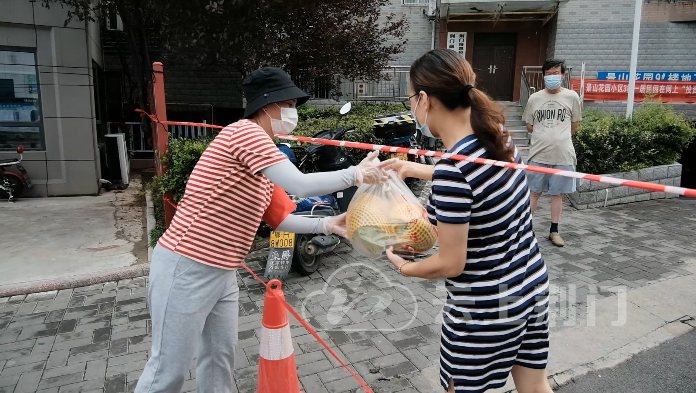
[0,174,147,293]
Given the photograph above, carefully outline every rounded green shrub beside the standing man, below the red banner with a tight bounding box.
[573,102,696,174]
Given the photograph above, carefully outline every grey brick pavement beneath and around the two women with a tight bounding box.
[0,200,696,393]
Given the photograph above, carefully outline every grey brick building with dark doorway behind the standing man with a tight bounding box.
[438,0,696,118]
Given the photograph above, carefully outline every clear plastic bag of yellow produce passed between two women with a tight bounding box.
[346,171,437,258]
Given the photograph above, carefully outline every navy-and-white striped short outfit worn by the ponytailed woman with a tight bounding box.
[427,135,549,393]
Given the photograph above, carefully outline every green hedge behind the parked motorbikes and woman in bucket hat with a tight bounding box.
[150,103,405,245]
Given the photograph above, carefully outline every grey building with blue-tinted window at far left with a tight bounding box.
[0,0,103,196]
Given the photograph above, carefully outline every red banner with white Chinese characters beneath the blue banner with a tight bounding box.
[571,79,696,104]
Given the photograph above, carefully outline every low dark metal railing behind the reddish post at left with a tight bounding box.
[106,121,214,153]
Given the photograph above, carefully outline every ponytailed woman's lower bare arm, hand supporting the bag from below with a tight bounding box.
[387,223,469,279]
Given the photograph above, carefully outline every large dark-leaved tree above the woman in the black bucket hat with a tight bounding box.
[42,0,408,102]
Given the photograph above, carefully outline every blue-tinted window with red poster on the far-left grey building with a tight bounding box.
[0,48,44,150]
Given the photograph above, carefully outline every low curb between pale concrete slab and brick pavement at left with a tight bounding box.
[0,263,150,297]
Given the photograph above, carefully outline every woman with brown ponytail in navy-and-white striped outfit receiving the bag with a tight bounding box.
[387,49,552,393]
